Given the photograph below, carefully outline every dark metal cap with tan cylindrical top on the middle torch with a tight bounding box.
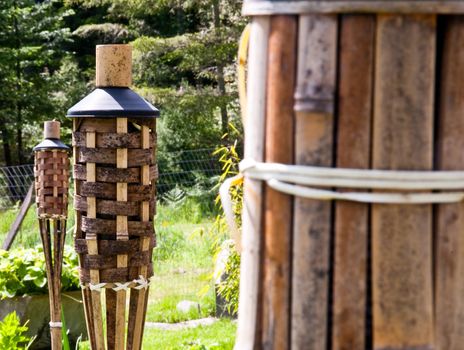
[67,45,159,118]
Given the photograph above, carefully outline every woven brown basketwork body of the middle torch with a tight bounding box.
[73,118,158,285]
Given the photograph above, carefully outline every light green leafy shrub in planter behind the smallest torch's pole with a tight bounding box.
[0,246,79,299]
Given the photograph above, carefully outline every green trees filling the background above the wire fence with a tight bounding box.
[0,0,245,166]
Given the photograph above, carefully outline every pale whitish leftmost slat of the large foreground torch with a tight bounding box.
[235,16,269,350]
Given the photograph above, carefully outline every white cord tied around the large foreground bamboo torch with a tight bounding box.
[219,159,464,246]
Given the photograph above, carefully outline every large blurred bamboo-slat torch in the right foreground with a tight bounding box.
[236,0,464,350]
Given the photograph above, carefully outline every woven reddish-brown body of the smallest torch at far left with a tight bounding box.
[34,150,69,218]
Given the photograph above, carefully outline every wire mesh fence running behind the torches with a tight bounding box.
[0,148,221,210]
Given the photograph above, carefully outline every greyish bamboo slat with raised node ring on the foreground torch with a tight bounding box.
[291,15,337,350]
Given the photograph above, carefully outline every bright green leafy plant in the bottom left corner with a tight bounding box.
[0,311,35,349]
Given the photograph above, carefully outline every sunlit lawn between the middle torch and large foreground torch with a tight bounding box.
[147,217,215,323]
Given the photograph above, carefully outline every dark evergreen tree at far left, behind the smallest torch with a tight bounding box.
[0,0,71,165]
